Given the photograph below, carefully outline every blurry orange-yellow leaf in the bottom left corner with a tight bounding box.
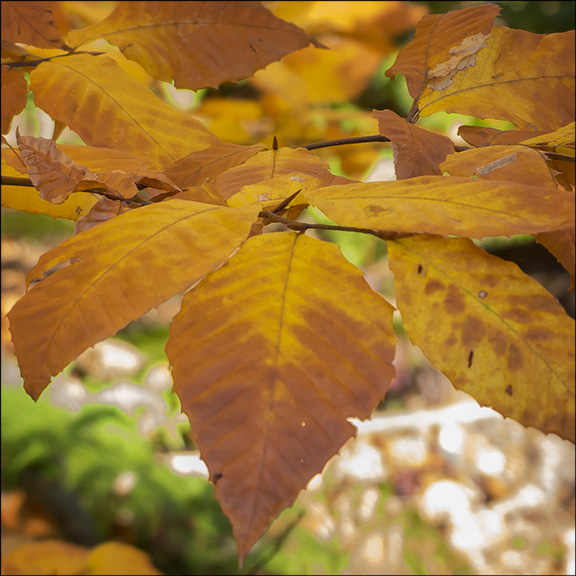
[2,540,89,576]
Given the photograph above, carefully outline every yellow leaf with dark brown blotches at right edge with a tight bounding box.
[388,236,575,442]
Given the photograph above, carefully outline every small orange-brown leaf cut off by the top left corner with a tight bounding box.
[2,0,68,49]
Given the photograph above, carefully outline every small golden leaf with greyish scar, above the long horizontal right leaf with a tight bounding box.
[440,146,558,189]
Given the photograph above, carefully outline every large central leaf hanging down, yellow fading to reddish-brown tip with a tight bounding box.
[166,232,394,559]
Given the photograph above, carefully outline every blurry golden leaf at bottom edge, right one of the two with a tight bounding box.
[82,541,163,576]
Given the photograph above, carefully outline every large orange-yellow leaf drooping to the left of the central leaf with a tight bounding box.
[8,200,258,399]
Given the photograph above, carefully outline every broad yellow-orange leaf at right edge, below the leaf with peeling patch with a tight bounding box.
[418,26,575,132]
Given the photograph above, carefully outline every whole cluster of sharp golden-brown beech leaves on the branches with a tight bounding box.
[2,2,575,561]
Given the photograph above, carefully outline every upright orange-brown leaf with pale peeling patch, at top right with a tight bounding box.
[386,4,500,99]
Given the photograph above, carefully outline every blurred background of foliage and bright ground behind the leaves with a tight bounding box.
[1,1,575,575]
